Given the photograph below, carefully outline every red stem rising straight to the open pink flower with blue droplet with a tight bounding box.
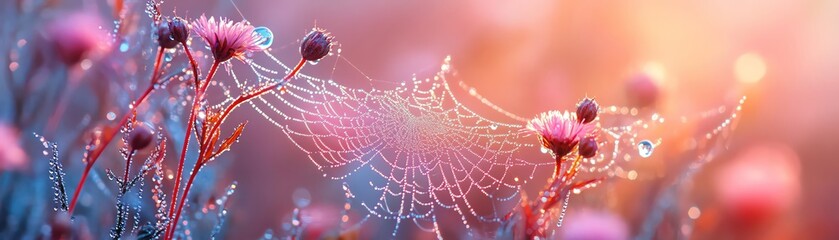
[164,62,220,239]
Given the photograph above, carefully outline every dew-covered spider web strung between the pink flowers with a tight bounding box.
[212,44,740,237]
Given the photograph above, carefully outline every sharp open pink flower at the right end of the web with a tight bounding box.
[527,111,595,157]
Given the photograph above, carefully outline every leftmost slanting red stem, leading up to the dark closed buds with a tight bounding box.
[67,48,163,215]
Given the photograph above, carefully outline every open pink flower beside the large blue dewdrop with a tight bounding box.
[192,15,264,62]
